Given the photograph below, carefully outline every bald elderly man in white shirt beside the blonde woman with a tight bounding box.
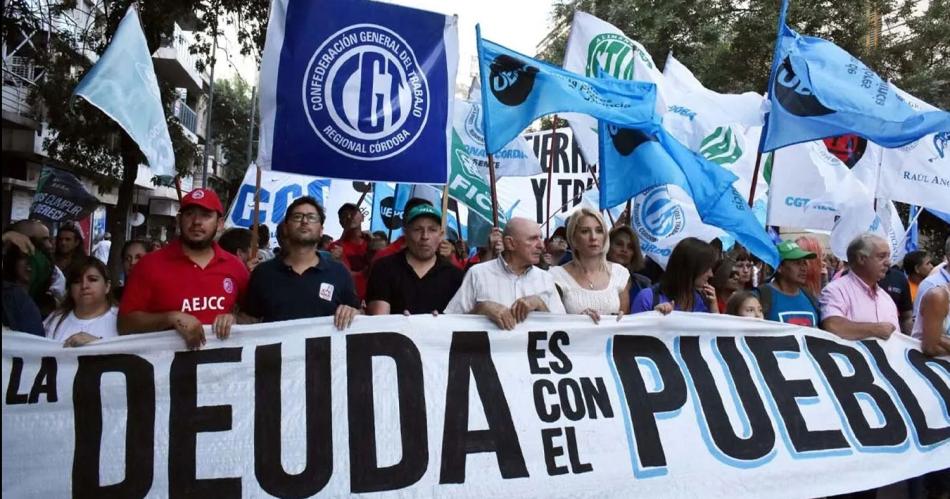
[445,218,564,329]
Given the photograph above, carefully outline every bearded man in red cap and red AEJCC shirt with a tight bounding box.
[118,189,250,349]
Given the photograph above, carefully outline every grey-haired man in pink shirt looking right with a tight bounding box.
[819,233,900,340]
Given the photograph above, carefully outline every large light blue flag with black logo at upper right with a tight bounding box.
[762,1,950,152]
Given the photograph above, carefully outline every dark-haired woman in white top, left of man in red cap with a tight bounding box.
[44,256,119,347]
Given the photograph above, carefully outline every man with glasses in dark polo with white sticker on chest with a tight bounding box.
[243,196,360,329]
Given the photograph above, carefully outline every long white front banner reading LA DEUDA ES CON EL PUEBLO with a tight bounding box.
[2,313,950,498]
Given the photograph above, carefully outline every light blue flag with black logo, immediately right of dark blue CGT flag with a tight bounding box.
[475,26,656,154]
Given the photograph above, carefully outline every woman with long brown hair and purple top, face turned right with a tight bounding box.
[630,237,719,314]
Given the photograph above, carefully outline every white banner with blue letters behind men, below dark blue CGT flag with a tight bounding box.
[224,165,330,247]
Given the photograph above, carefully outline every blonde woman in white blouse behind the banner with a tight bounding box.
[549,208,630,323]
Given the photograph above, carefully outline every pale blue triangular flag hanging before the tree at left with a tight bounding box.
[73,4,175,177]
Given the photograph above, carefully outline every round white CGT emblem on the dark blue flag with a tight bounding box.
[303,24,430,161]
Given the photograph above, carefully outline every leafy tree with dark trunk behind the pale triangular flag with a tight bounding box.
[2,0,269,276]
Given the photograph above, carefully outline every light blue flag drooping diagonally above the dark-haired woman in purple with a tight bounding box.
[598,121,779,267]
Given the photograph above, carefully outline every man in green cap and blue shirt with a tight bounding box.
[756,241,821,327]
